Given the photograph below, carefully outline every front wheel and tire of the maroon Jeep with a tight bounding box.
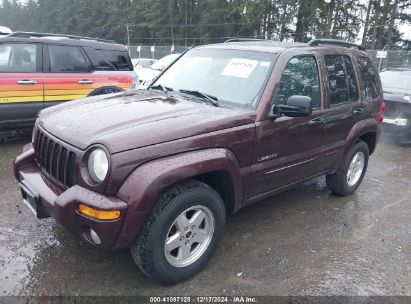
[130,180,226,285]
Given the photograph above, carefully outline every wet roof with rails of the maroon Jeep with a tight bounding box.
[197,39,363,54]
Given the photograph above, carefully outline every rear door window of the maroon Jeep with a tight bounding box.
[325,55,358,105]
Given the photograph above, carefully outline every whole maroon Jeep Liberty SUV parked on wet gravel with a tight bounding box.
[15,39,384,284]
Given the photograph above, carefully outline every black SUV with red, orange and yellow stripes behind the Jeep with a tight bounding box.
[0,32,138,140]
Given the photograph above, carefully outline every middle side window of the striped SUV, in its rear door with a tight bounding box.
[48,45,88,73]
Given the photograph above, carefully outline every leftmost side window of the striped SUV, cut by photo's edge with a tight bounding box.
[0,43,37,73]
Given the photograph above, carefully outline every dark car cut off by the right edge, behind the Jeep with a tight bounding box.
[380,67,411,143]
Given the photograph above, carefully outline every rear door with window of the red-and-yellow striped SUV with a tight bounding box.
[44,45,101,107]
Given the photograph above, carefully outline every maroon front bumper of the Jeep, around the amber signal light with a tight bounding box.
[14,146,127,249]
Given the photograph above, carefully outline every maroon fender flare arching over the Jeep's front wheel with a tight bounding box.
[114,148,243,248]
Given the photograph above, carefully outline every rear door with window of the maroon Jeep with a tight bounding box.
[321,52,365,169]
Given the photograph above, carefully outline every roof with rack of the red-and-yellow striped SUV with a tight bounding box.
[0,36,126,51]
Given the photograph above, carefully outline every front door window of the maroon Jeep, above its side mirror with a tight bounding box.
[274,56,321,109]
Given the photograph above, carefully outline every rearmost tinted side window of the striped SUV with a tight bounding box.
[84,47,133,71]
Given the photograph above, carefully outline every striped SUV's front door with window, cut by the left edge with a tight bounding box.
[0,42,43,129]
